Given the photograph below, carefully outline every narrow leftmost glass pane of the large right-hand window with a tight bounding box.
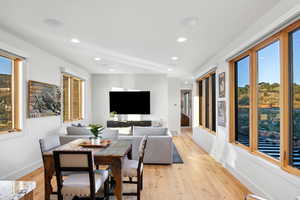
[235,56,250,146]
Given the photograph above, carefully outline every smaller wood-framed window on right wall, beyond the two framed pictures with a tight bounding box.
[198,72,216,132]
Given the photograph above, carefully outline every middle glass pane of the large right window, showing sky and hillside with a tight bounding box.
[257,41,280,159]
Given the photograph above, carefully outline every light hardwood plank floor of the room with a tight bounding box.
[21,129,249,200]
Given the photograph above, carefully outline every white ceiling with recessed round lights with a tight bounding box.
[0,0,279,76]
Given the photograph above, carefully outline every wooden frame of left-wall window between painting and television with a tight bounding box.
[62,74,84,123]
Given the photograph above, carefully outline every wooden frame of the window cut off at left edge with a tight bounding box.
[0,53,22,134]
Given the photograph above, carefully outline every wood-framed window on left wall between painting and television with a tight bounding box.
[63,75,84,122]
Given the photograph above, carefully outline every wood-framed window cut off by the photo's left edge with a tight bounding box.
[0,54,21,133]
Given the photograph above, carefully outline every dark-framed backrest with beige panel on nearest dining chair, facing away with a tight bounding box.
[53,151,95,195]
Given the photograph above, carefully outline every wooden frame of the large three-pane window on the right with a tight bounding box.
[229,20,300,176]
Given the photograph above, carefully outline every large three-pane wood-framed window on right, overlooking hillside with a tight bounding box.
[229,20,300,175]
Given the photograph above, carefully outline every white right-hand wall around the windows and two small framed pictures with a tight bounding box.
[193,0,300,200]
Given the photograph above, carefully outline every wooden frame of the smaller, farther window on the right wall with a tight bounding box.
[197,70,216,134]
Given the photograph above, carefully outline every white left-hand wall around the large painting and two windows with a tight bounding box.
[0,26,91,179]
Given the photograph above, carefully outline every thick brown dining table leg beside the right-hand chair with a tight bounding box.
[111,158,123,200]
